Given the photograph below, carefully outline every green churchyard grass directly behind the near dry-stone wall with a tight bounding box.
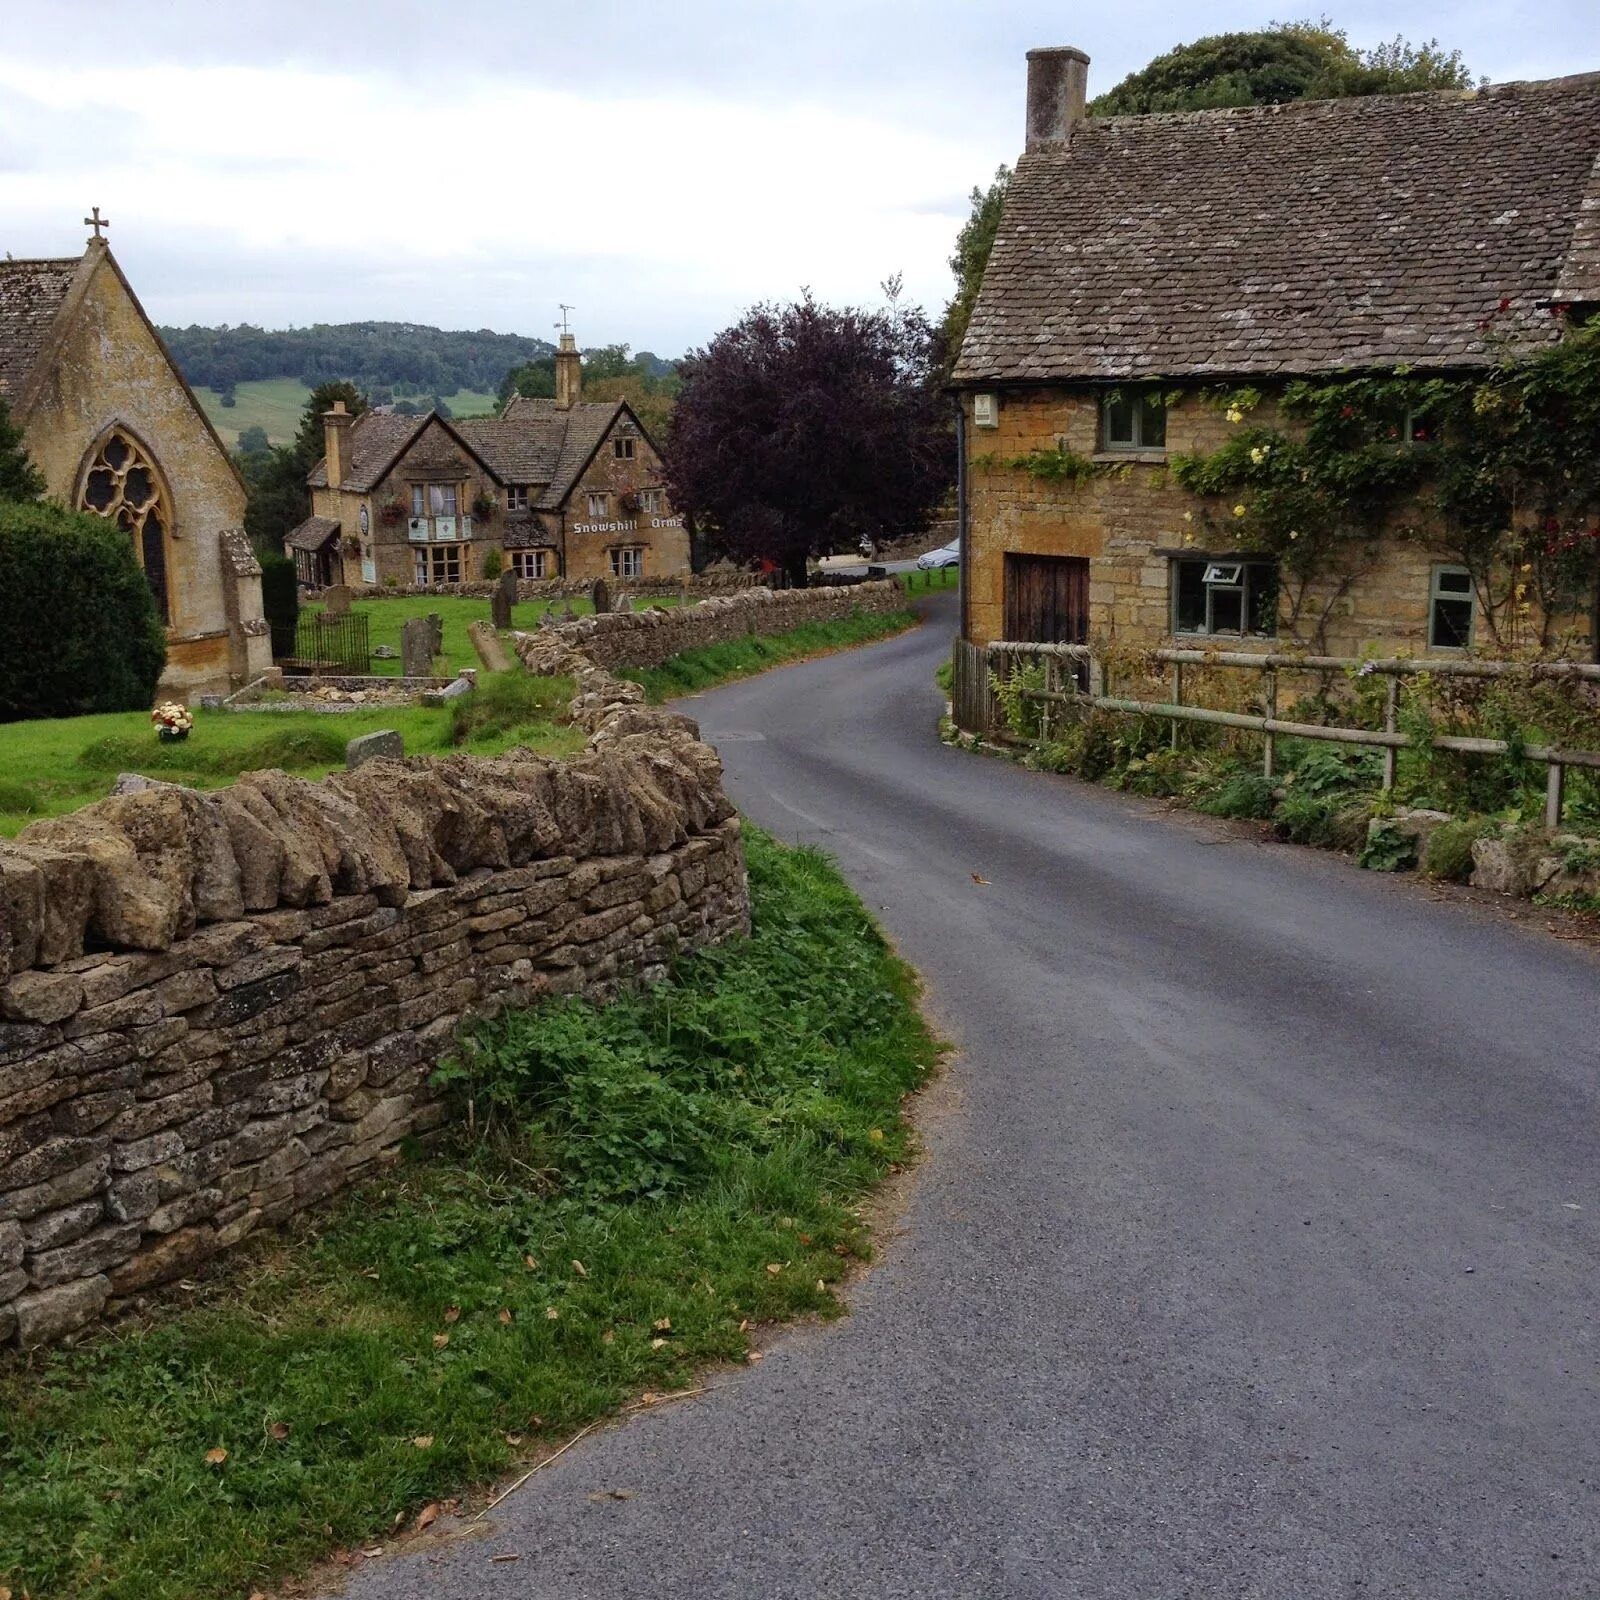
[0,669,584,837]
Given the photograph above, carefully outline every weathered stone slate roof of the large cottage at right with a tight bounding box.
[954,74,1600,384]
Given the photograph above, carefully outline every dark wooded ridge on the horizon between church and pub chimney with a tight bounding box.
[162,322,555,402]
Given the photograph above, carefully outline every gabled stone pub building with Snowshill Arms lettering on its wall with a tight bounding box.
[285,333,690,587]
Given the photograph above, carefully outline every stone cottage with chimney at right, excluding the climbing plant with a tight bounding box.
[954,50,1600,654]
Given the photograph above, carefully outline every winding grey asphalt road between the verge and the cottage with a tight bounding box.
[349,600,1600,1600]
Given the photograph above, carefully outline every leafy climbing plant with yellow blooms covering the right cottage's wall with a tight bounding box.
[1170,315,1600,654]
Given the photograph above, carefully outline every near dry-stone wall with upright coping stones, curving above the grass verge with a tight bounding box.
[0,650,749,1347]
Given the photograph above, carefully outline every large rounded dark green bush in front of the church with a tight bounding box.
[0,502,166,722]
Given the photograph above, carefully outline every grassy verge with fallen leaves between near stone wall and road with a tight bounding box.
[0,829,938,1600]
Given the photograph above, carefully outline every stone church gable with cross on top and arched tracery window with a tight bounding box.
[0,219,272,699]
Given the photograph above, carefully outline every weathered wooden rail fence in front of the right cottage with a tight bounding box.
[952,640,1600,829]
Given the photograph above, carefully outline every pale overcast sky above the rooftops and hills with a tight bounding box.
[0,0,1600,355]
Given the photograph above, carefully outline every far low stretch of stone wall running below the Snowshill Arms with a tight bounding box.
[515,578,906,675]
